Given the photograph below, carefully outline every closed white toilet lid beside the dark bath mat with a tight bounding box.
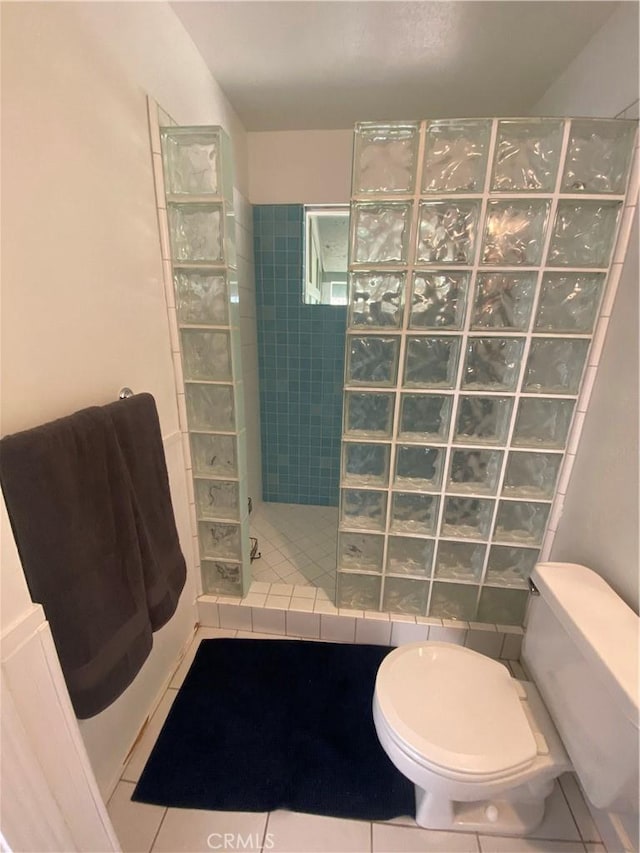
[376,642,537,777]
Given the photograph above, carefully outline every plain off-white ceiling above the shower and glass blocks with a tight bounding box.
[171,0,619,131]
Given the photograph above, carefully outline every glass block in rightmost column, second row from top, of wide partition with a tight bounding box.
[547,201,622,267]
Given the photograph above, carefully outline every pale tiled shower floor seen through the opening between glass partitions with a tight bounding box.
[249,503,338,601]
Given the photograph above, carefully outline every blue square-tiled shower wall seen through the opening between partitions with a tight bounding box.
[253,204,347,506]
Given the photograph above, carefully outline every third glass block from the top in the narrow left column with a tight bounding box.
[173,270,229,326]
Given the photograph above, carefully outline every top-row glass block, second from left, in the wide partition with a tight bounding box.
[422,119,491,193]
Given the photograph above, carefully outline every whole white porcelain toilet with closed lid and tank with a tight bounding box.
[373,563,640,835]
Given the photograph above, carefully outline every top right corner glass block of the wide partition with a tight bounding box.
[562,119,637,195]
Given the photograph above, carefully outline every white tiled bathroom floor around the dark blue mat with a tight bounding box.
[108,628,606,853]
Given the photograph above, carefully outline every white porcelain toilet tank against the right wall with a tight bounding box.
[522,563,640,812]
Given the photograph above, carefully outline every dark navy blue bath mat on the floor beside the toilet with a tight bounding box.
[133,639,415,820]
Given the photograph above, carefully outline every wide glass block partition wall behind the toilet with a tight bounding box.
[337,119,636,625]
